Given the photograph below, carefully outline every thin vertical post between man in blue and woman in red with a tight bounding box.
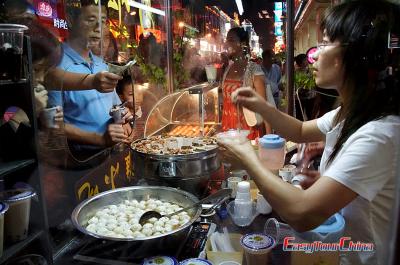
[164,0,174,94]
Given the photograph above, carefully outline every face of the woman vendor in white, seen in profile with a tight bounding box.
[312,36,344,89]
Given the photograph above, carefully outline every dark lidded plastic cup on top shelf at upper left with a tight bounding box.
[0,24,28,81]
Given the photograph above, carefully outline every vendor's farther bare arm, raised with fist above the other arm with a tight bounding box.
[232,88,325,143]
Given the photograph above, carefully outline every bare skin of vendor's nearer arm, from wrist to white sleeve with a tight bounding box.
[246,151,357,232]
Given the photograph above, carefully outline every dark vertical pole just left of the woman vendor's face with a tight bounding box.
[286,0,294,116]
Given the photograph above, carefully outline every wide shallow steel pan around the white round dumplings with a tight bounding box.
[71,186,201,260]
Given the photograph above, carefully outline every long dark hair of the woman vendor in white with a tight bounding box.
[321,0,400,163]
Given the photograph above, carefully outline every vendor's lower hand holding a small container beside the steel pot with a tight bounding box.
[218,138,258,169]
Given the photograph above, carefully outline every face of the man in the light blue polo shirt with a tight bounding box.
[72,5,107,48]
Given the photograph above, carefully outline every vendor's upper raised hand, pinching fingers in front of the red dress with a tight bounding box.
[231,87,269,113]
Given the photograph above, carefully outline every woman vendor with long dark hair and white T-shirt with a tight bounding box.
[222,0,400,265]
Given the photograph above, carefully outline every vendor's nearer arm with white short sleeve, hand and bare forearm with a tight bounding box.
[220,122,397,231]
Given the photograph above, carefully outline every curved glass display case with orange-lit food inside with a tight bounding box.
[144,83,220,137]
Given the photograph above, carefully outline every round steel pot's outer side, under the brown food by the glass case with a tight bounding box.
[133,140,221,197]
